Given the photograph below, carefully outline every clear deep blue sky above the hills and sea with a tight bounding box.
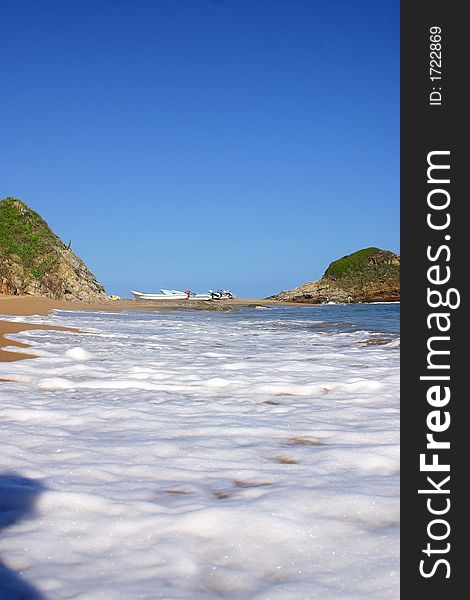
[0,0,399,297]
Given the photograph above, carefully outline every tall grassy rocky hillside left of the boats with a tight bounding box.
[0,198,108,302]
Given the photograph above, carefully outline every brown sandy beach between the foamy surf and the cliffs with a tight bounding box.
[0,295,305,362]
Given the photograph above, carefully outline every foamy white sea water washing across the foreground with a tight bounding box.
[0,304,399,600]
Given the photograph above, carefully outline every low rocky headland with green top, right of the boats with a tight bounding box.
[270,248,400,304]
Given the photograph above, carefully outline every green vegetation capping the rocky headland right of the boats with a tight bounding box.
[323,248,400,285]
